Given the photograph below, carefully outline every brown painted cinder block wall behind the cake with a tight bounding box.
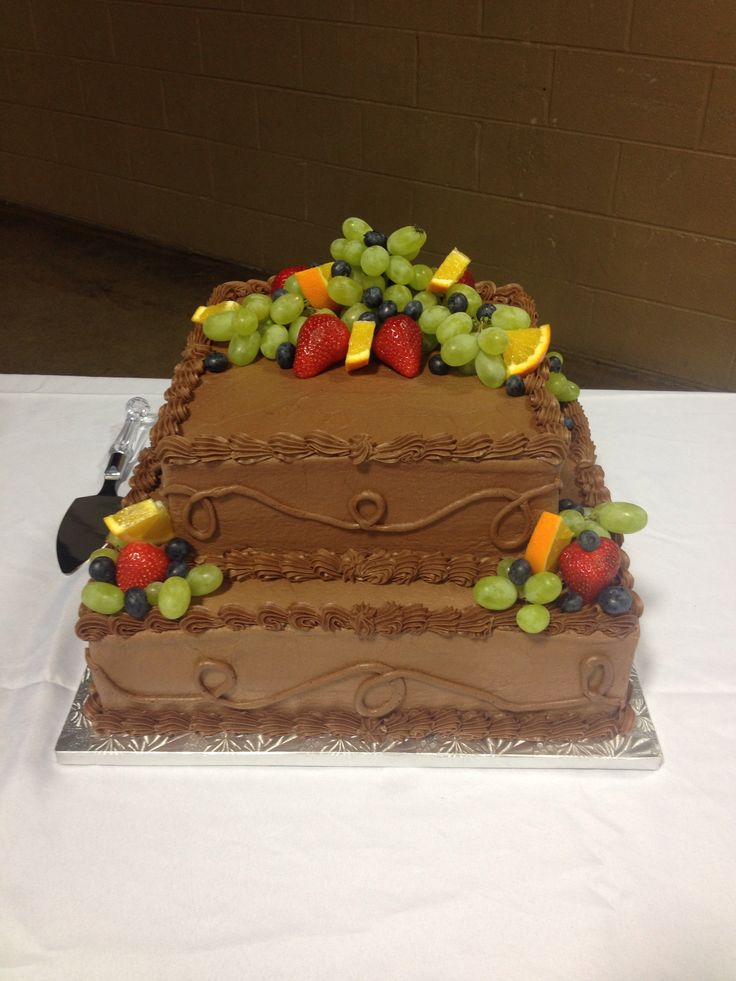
[0,0,736,389]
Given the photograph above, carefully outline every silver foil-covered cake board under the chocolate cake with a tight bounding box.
[56,669,663,770]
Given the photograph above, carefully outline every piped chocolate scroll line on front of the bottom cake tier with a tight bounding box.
[88,655,623,718]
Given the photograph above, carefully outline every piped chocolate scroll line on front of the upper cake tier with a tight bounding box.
[165,478,561,551]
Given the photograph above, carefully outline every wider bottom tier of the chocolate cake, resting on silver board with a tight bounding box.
[78,580,639,742]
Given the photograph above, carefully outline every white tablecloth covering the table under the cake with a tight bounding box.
[0,375,736,981]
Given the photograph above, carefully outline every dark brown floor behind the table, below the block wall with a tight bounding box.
[0,203,700,390]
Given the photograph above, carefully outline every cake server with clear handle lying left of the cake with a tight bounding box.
[56,396,155,572]
